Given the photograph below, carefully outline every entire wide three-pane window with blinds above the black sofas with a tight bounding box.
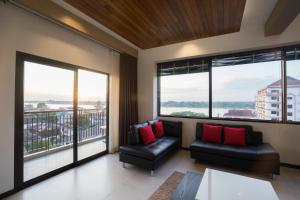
[158,44,300,122]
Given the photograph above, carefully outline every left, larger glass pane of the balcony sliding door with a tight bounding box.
[23,62,74,181]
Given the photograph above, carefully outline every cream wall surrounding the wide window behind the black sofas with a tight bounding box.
[138,4,300,165]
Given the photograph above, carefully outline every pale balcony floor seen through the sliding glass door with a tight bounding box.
[24,140,106,181]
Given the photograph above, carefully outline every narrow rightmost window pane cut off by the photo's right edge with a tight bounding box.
[286,60,300,122]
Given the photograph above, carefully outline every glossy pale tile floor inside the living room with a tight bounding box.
[7,151,300,200]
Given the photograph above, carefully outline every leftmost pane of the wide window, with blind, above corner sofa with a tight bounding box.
[159,60,209,118]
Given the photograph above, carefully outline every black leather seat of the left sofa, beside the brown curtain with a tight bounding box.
[120,136,179,160]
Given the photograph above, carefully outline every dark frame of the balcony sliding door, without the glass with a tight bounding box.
[14,51,110,191]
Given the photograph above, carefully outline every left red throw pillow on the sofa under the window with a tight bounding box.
[202,124,223,143]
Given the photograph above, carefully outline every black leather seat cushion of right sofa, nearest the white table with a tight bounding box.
[190,140,279,160]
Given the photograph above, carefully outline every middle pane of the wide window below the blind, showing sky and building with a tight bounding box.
[212,61,281,121]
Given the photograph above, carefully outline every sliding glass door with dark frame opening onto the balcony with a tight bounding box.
[15,52,109,188]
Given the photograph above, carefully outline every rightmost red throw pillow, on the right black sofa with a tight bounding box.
[224,127,246,146]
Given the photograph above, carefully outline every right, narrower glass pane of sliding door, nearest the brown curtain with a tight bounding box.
[78,70,108,160]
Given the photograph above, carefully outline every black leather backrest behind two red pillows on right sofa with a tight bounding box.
[196,122,261,145]
